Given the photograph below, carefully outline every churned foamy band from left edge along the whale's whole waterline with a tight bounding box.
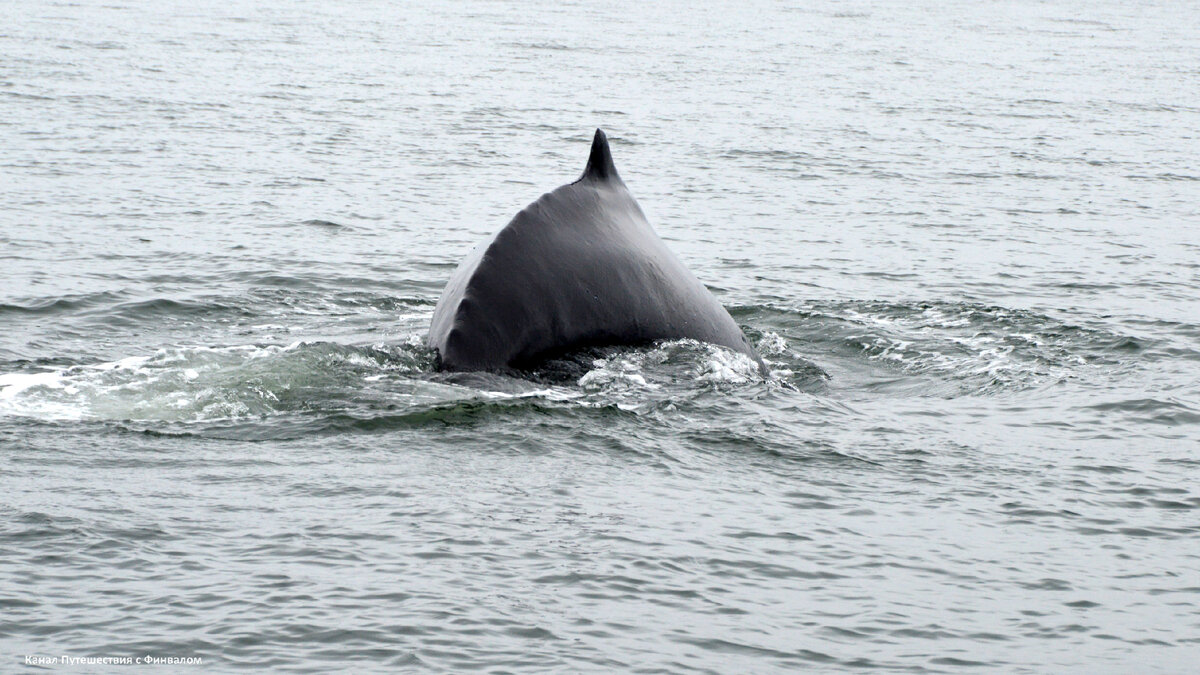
[0,325,820,427]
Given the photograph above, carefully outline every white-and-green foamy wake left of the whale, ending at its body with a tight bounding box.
[0,342,438,422]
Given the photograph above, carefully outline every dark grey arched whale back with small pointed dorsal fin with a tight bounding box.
[428,129,764,371]
